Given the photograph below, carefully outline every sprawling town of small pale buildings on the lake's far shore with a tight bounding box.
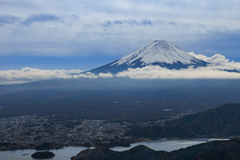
[0,115,129,151]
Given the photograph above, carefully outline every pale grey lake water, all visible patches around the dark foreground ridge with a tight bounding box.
[0,138,228,160]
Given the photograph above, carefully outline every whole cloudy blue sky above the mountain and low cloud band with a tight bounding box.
[0,0,240,70]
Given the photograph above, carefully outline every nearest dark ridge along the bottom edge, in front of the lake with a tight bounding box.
[71,139,240,160]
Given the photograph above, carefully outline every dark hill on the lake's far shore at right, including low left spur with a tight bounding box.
[125,104,240,138]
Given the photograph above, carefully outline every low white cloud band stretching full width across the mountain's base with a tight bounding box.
[0,52,240,84]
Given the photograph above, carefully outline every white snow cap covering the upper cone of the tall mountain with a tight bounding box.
[111,40,195,66]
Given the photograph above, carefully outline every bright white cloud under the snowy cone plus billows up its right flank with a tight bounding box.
[116,52,240,79]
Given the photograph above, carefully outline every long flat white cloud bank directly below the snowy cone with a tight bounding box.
[116,66,240,79]
